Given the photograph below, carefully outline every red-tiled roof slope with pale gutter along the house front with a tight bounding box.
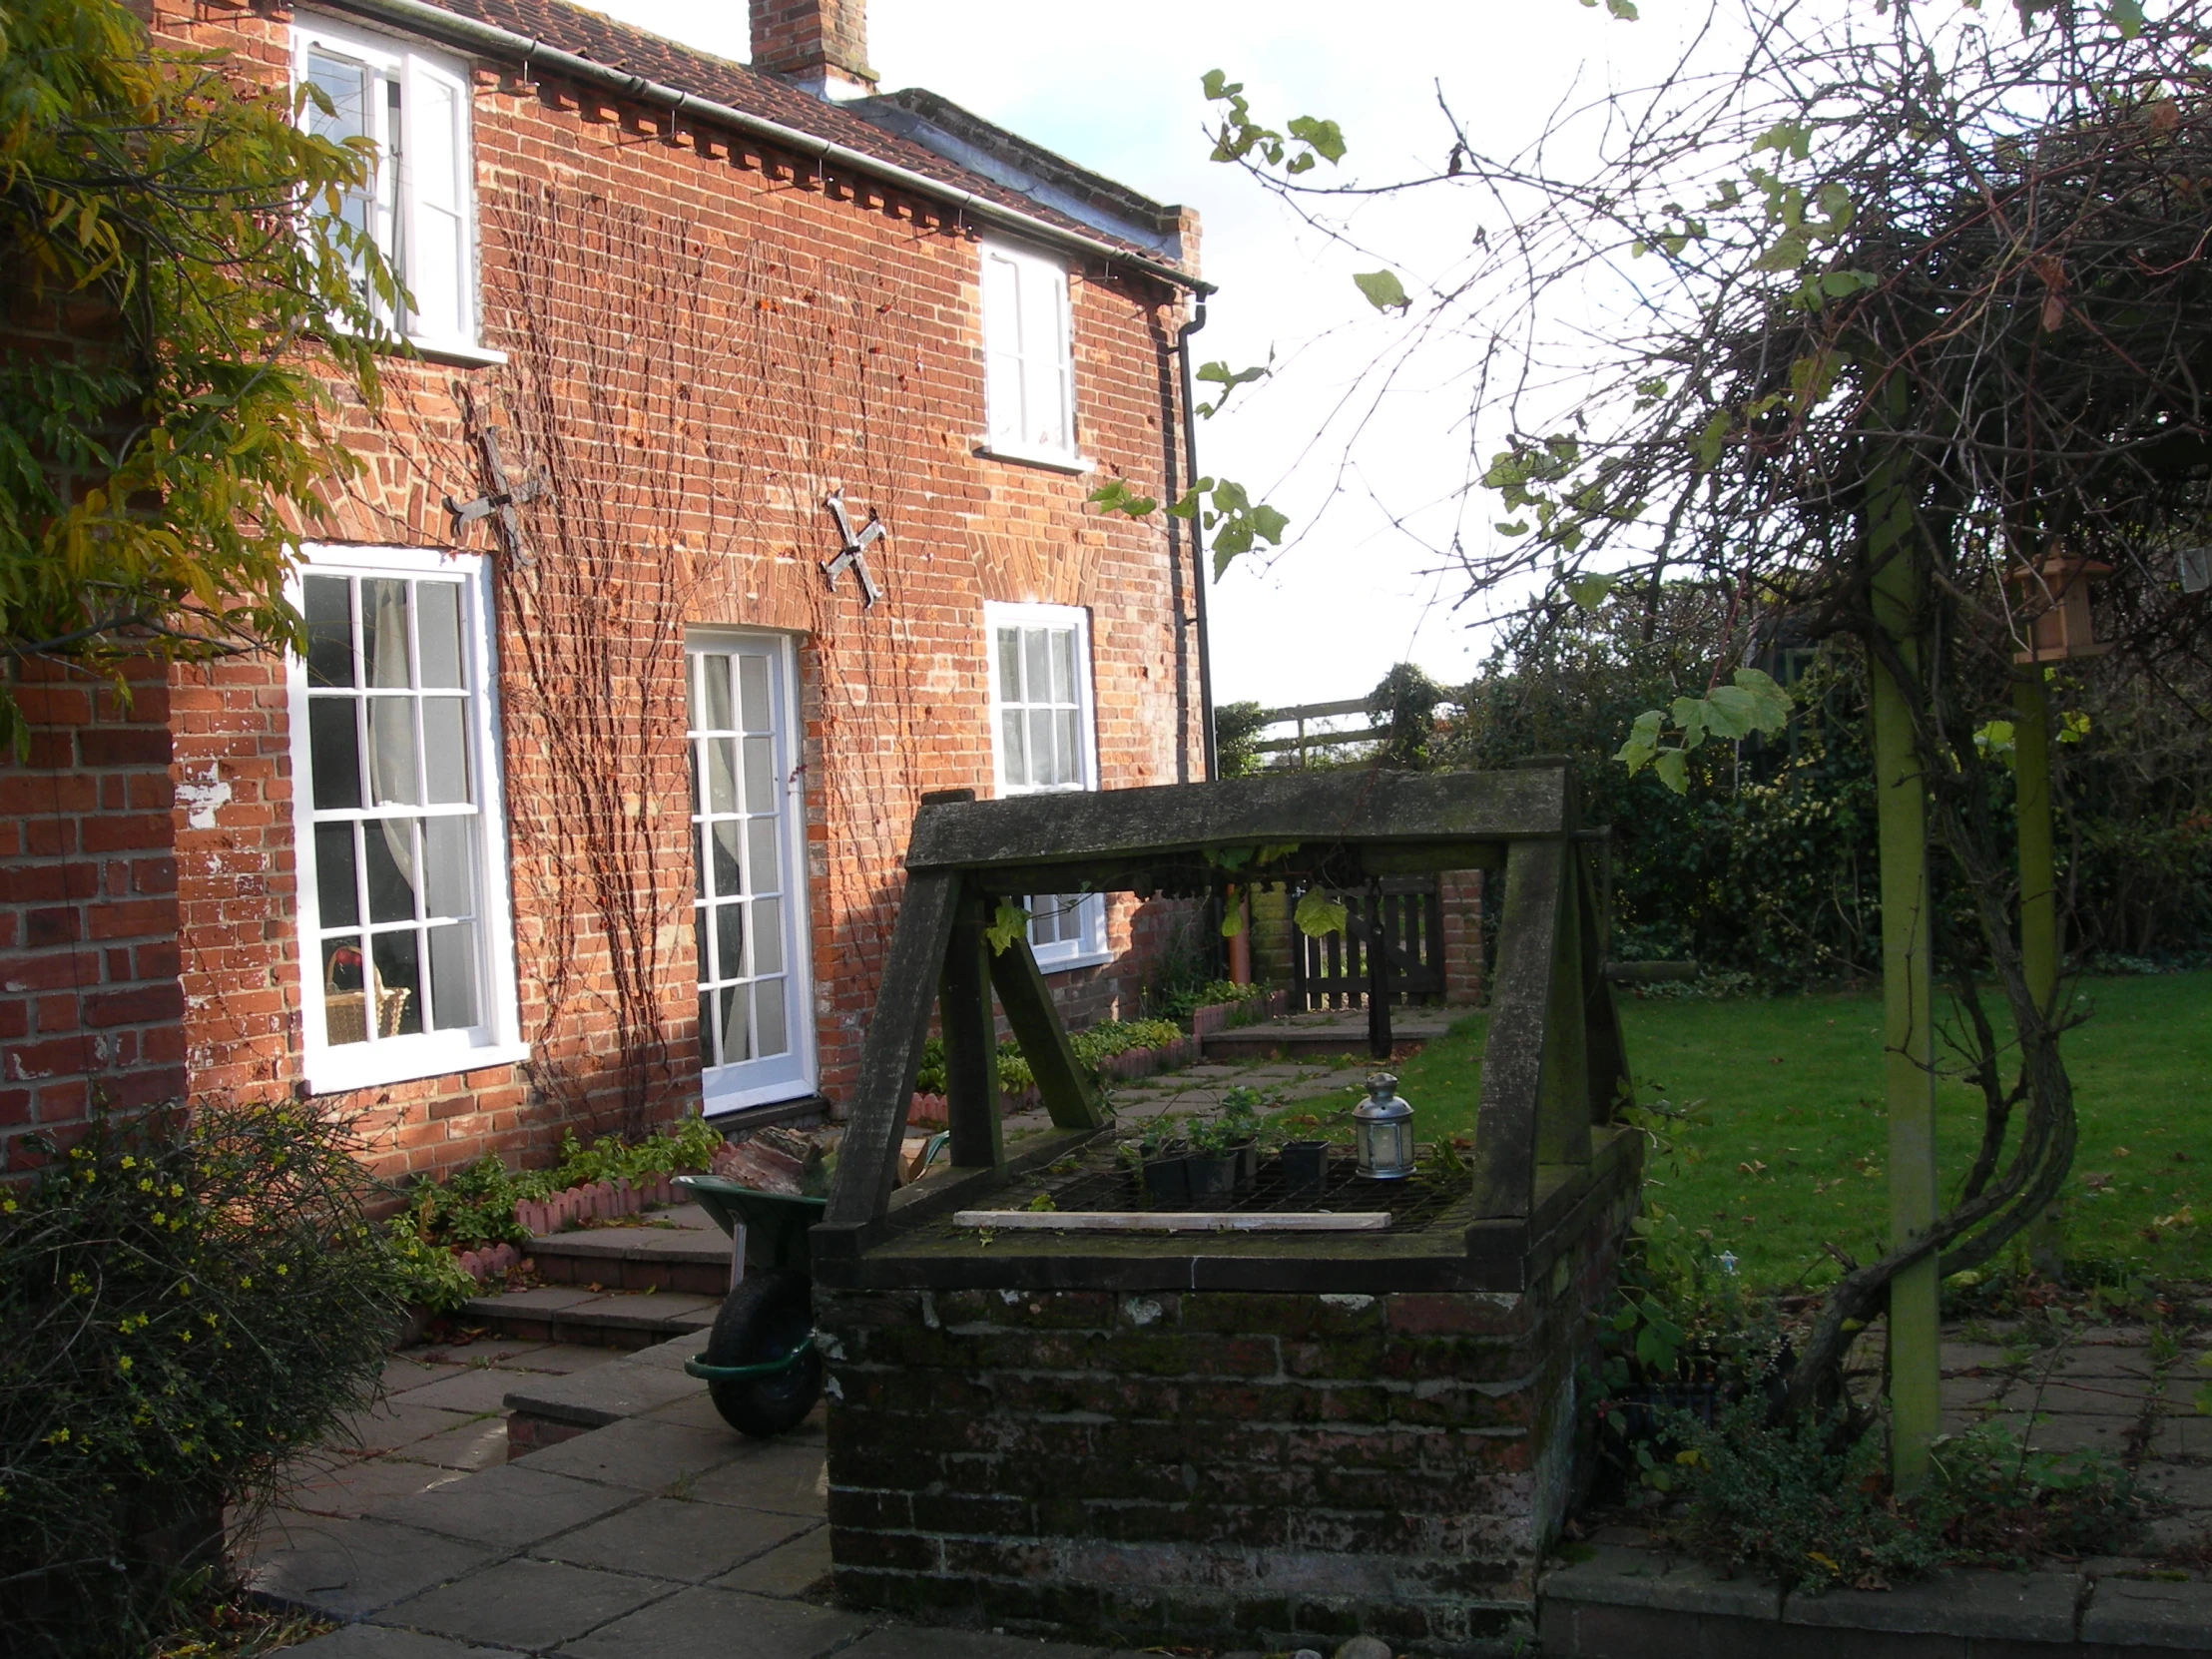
[303,0,1215,294]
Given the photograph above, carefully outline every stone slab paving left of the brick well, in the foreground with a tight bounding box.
[246,1339,1135,1659]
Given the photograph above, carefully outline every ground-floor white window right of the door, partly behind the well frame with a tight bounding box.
[984,604,1113,969]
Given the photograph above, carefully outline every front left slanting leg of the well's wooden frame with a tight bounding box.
[823,869,960,1228]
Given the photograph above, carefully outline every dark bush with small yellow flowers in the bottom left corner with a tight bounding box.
[0,1104,405,1655]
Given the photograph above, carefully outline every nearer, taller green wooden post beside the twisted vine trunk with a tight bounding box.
[1867,415,1942,1493]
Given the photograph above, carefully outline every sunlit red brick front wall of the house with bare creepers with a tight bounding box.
[151,7,1199,1194]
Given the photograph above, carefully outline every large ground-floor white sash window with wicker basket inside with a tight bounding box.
[289,549,526,1093]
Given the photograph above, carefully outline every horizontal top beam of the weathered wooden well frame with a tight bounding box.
[907,768,1570,869]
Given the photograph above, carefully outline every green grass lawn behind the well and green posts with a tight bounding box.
[1354,973,2212,1285]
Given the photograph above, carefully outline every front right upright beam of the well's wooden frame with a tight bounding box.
[1475,840,1568,1219]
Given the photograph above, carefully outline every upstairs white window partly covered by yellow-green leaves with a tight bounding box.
[292,16,480,356]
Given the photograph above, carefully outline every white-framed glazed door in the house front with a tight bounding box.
[684,633,814,1113]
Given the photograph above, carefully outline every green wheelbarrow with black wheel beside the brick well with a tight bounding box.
[675,1135,949,1440]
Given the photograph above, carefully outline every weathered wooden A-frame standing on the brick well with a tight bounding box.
[814,764,1630,1277]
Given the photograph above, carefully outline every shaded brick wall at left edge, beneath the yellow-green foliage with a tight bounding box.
[0,662,186,1170]
